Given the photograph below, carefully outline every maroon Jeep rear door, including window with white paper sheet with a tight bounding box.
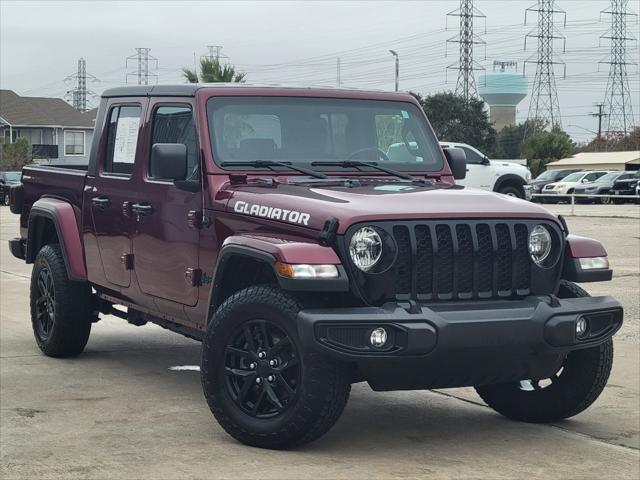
[85,99,146,287]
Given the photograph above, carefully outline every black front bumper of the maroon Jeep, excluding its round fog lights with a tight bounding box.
[298,296,623,390]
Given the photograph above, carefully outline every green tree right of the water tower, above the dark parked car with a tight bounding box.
[521,128,575,177]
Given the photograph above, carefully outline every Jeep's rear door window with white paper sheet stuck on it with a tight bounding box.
[103,105,142,175]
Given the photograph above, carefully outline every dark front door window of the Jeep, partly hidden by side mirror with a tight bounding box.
[148,105,200,180]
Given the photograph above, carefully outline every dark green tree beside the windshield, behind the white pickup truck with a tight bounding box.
[412,92,496,156]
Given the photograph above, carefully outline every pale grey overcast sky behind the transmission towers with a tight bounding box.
[0,0,640,140]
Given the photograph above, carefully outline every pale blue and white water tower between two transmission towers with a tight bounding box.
[478,61,529,131]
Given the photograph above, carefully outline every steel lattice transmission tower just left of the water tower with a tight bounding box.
[445,0,486,102]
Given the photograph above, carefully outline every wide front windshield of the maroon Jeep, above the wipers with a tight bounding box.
[207,97,442,172]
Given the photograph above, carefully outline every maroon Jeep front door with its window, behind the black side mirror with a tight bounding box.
[132,99,202,305]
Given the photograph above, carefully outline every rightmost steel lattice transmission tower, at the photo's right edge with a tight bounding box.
[600,0,635,135]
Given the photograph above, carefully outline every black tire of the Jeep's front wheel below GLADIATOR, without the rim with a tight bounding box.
[201,285,351,449]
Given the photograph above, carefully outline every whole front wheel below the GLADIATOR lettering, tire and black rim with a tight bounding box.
[201,285,351,449]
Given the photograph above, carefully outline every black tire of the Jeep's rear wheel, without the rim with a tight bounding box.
[30,244,95,358]
